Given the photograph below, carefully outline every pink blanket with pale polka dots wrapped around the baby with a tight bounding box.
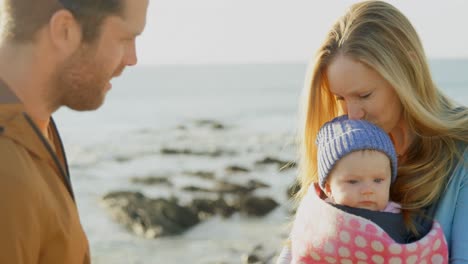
[291,188,448,264]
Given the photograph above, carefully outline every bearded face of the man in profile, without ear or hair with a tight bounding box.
[56,0,148,111]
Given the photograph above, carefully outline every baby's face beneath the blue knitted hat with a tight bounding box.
[325,150,391,211]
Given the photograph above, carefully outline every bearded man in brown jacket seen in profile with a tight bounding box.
[0,0,149,264]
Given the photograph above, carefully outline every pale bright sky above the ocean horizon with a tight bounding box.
[137,0,468,65]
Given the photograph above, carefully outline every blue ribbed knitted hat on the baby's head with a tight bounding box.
[316,115,397,189]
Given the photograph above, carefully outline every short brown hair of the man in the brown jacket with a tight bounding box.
[0,0,124,43]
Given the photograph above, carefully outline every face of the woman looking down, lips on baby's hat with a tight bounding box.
[327,55,402,133]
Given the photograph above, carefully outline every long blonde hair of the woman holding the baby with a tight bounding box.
[297,1,468,231]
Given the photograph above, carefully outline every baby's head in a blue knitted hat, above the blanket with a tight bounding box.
[316,116,400,213]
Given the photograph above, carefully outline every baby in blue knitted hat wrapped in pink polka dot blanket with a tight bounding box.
[291,116,448,264]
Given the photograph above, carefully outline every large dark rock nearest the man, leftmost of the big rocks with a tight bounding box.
[102,191,200,238]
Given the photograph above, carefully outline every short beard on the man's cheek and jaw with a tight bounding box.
[52,47,112,111]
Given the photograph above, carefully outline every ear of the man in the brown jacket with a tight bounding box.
[49,9,82,56]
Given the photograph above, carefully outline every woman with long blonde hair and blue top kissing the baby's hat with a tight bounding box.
[278,1,468,263]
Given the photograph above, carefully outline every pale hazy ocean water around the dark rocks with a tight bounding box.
[54,60,468,264]
